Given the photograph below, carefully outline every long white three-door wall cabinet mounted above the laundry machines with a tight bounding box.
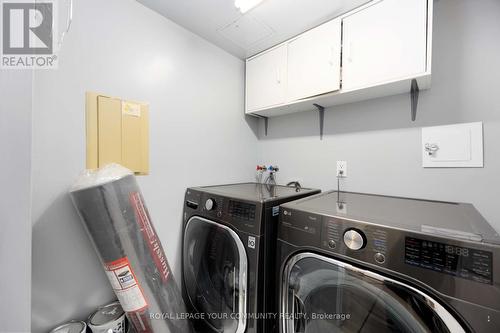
[246,0,433,117]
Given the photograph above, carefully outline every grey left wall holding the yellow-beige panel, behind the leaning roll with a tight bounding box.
[32,0,257,333]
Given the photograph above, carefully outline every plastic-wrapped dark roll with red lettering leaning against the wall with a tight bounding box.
[70,164,191,333]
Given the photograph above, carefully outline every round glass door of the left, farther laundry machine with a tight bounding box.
[183,217,247,333]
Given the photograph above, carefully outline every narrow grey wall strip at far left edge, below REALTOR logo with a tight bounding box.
[0,69,32,332]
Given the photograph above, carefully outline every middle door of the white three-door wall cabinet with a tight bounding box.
[287,19,342,101]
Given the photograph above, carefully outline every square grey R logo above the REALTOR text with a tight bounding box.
[2,2,54,54]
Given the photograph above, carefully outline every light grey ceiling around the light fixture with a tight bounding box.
[137,0,369,59]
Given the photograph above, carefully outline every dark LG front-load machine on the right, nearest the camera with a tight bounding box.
[278,192,500,333]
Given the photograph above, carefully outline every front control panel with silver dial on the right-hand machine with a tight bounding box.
[278,205,500,308]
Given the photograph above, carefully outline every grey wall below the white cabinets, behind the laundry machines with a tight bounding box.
[259,0,500,231]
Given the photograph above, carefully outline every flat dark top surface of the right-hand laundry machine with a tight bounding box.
[282,191,500,244]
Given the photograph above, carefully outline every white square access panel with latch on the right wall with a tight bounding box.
[422,122,484,168]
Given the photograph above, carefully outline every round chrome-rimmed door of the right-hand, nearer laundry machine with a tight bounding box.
[281,253,465,333]
